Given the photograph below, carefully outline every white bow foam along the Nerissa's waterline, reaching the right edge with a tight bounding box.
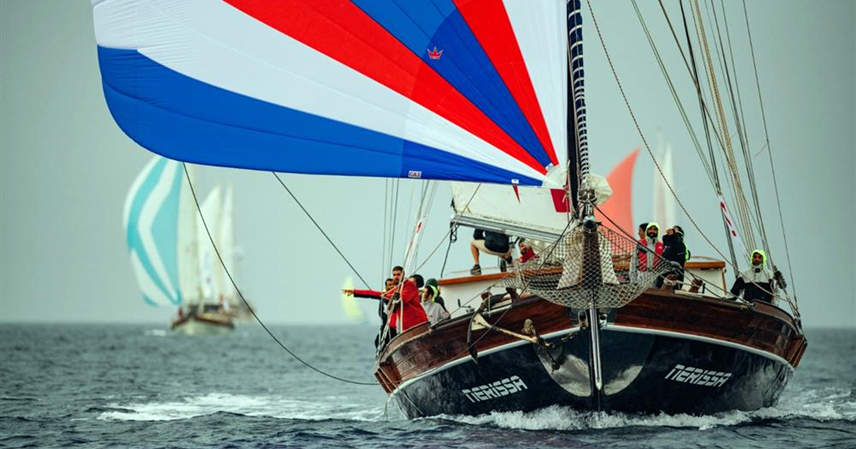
[442,388,856,430]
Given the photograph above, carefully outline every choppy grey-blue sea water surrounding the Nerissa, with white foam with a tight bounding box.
[0,324,856,449]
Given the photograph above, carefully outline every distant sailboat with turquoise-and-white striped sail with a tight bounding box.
[124,156,234,334]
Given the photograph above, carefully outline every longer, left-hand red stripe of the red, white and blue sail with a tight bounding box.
[225,0,546,174]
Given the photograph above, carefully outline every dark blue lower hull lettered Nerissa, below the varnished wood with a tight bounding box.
[392,325,793,418]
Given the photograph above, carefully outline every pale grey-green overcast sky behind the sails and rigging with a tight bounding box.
[0,0,856,326]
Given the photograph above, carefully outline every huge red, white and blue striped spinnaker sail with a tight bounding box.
[93,0,568,188]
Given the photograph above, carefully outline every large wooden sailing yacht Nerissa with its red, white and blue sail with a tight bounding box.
[93,0,807,417]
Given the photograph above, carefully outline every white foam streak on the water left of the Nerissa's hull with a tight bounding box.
[98,393,383,421]
